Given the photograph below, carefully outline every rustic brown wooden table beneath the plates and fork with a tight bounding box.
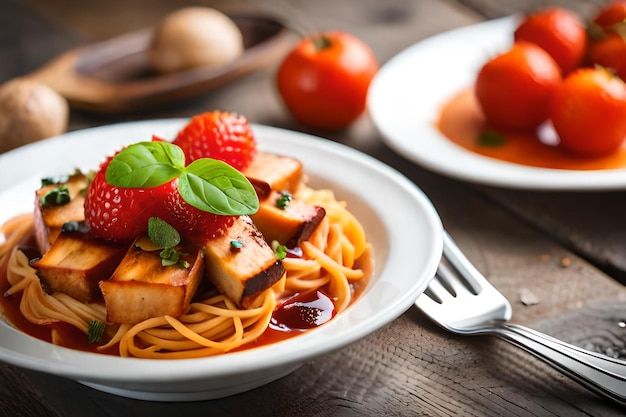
[0,0,626,417]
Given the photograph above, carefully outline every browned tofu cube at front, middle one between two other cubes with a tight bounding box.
[100,236,204,324]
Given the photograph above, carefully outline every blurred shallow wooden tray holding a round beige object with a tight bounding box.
[28,16,294,114]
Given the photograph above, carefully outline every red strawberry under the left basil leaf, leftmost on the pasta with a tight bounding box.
[84,157,178,243]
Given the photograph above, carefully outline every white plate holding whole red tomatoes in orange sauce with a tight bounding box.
[368,16,626,190]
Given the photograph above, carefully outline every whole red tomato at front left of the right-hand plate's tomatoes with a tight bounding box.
[475,41,562,130]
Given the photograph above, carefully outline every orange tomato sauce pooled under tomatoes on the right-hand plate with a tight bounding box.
[437,89,626,170]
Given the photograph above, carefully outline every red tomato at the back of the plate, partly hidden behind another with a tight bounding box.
[514,7,587,74]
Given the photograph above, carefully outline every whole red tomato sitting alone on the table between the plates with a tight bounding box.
[277,31,378,130]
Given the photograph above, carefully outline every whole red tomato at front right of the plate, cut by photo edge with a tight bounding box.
[550,68,626,156]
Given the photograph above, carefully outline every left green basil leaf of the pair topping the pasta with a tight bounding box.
[105,142,185,188]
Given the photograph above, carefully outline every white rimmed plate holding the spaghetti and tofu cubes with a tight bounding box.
[0,119,443,401]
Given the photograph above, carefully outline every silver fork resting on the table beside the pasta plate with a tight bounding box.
[415,232,626,405]
